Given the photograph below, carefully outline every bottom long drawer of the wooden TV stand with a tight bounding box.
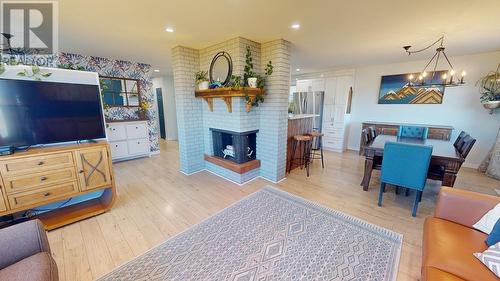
[7,182,78,209]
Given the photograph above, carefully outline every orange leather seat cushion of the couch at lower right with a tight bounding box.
[422,218,498,281]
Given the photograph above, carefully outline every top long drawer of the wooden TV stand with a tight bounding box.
[0,152,74,176]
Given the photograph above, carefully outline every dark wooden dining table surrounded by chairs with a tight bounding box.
[361,135,464,191]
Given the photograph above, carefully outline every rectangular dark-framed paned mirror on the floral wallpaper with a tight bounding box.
[100,76,141,107]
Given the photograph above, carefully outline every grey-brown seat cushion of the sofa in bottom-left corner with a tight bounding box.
[0,252,58,281]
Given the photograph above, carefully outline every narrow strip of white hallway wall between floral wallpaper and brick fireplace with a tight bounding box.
[153,75,177,140]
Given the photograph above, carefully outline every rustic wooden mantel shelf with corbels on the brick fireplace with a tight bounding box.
[195,87,265,112]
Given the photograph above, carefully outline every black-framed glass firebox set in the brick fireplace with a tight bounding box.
[210,128,259,164]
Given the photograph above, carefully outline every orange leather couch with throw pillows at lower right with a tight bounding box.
[422,187,500,281]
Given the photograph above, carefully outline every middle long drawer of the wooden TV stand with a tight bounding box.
[4,167,77,194]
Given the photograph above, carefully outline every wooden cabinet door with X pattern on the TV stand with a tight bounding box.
[76,147,111,191]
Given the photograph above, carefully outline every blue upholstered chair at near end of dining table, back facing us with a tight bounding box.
[378,142,432,217]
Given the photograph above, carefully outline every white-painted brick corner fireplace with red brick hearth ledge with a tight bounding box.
[172,37,291,184]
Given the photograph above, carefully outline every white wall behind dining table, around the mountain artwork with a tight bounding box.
[348,51,500,167]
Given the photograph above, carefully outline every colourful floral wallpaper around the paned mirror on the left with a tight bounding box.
[55,53,160,152]
